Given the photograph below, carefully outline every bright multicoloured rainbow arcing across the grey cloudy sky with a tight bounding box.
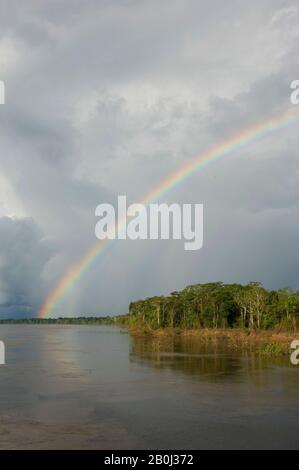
[38,106,299,318]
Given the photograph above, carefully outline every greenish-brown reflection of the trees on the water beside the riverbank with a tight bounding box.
[130,336,291,382]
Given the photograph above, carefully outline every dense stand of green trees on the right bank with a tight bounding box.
[127,282,299,331]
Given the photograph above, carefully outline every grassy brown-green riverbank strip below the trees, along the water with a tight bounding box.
[128,327,299,355]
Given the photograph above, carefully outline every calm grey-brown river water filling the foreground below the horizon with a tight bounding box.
[0,325,299,449]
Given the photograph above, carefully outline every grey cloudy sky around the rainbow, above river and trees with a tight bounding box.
[0,0,299,318]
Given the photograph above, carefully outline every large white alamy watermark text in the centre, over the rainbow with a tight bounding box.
[95,196,203,251]
